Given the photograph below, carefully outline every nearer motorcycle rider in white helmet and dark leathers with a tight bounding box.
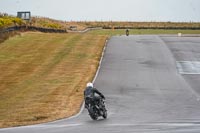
[84,82,105,109]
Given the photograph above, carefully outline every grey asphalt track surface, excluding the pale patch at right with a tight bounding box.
[0,35,200,133]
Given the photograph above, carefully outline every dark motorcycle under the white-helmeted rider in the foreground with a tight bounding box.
[85,97,107,120]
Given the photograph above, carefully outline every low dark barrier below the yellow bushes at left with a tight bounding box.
[0,26,67,33]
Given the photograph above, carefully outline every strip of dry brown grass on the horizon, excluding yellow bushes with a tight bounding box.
[29,17,200,30]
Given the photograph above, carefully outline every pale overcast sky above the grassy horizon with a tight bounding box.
[0,0,200,22]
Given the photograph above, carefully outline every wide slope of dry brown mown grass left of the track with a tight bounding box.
[0,32,106,127]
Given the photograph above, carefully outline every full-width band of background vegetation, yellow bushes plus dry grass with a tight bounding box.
[0,13,200,30]
